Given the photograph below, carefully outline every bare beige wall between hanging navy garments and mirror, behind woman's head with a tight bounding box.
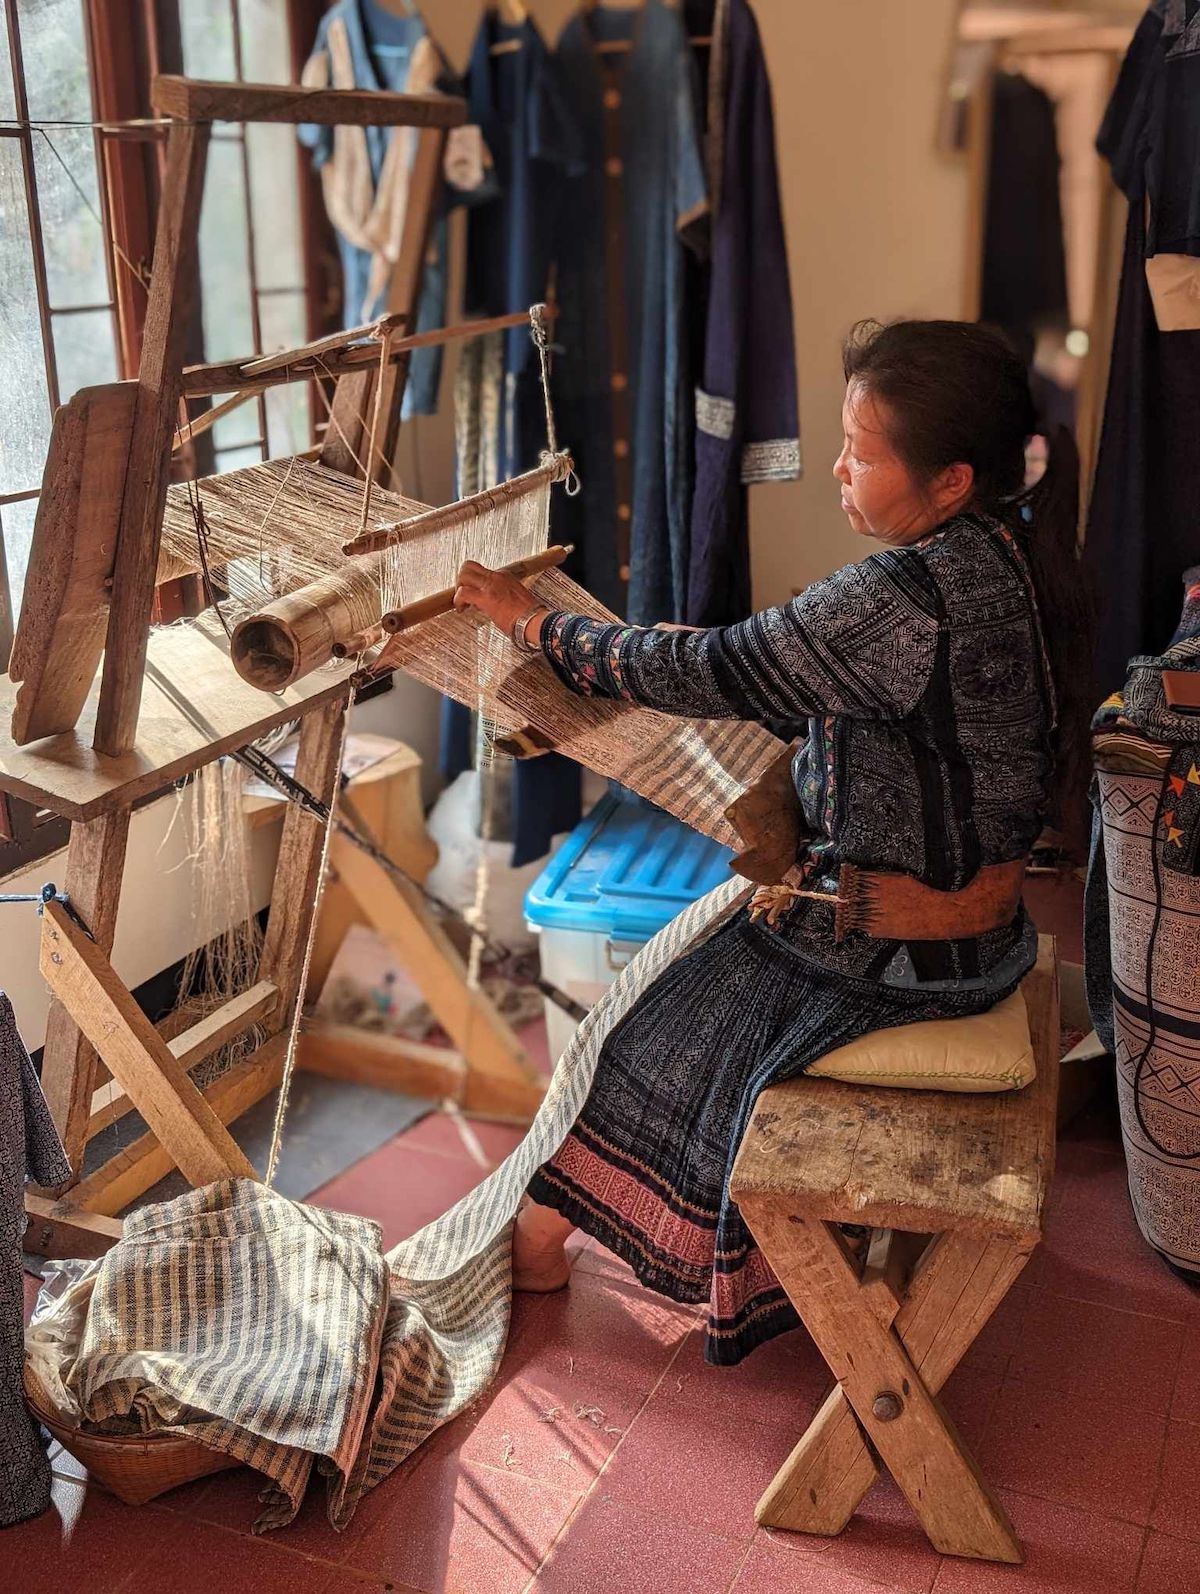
[751,0,967,603]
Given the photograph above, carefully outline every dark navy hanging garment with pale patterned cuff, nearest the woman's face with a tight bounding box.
[682,0,800,625]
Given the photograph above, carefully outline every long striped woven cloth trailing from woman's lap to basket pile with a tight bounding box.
[70,878,749,1530]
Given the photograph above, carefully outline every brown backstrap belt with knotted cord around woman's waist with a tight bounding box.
[751,858,1026,942]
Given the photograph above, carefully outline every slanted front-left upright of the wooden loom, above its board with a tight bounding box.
[94,123,210,757]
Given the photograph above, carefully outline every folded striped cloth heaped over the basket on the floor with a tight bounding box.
[67,1180,389,1529]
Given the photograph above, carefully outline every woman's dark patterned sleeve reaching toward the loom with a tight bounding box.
[542,548,940,720]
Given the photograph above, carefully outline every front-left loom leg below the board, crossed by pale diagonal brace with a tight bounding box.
[41,808,129,1184]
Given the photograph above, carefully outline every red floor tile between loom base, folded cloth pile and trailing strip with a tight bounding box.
[309,1141,484,1250]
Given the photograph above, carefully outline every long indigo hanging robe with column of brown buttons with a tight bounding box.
[555,0,708,622]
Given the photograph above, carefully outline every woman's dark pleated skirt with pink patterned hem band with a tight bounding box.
[529,913,994,1366]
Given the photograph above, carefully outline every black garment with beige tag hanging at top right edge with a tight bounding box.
[1085,0,1200,690]
